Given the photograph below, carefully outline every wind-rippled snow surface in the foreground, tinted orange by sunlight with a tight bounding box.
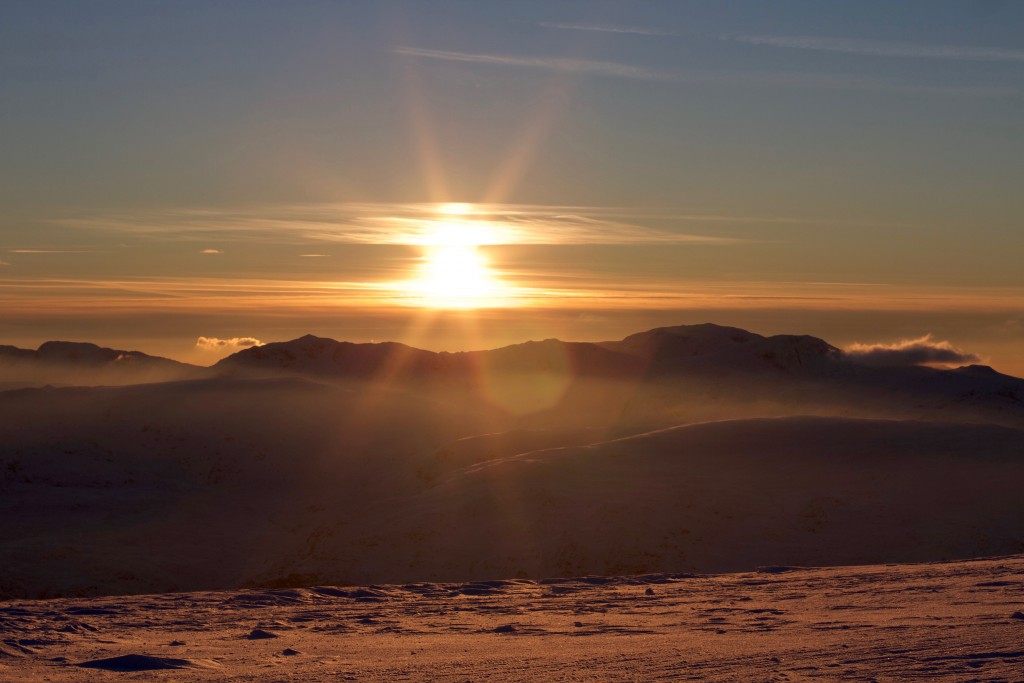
[0,557,1024,683]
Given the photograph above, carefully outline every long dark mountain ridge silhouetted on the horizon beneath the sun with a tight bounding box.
[205,324,1024,433]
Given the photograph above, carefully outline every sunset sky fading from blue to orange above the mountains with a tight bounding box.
[0,0,1024,376]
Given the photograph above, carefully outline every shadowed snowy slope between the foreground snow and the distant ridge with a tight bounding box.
[0,389,1024,596]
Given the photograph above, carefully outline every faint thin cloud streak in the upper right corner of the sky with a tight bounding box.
[721,34,1024,61]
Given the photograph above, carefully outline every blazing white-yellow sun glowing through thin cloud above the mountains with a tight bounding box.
[406,212,509,308]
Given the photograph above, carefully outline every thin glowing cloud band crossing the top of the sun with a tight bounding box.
[56,204,749,248]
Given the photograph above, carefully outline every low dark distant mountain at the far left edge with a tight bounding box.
[0,341,205,385]
